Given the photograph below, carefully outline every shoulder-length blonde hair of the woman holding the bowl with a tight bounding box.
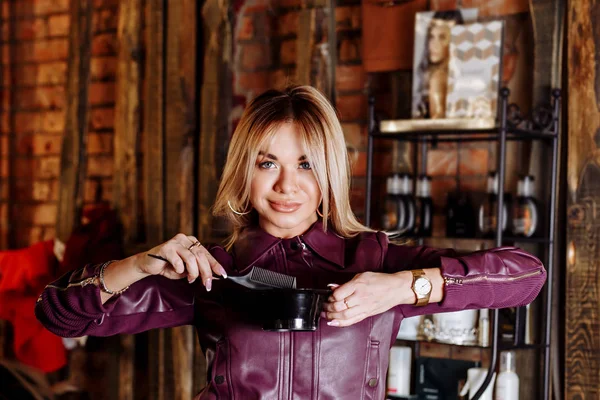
[213,86,371,248]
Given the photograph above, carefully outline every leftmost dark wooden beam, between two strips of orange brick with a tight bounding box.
[56,0,93,243]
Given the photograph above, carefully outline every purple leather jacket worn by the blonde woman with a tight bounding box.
[36,222,546,400]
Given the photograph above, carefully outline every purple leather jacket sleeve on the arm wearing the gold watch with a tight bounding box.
[380,233,546,317]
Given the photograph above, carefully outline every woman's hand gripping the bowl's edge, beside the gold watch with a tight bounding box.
[323,271,415,327]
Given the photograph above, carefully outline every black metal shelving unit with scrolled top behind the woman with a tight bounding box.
[365,88,560,400]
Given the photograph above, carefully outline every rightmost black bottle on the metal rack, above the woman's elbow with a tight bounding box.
[512,175,539,237]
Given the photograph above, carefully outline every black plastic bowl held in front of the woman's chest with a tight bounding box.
[254,289,332,332]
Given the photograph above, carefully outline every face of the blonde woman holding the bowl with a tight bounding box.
[250,123,321,238]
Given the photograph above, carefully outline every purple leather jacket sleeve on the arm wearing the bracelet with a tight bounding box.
[35,265,197,337]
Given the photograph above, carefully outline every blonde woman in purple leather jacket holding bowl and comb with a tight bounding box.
[36,86,545,400]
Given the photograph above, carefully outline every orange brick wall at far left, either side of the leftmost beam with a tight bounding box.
[0,0,118,247]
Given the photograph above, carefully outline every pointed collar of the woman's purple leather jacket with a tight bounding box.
[233,219,345,270]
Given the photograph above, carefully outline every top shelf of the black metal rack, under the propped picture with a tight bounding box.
[371,120,556,142]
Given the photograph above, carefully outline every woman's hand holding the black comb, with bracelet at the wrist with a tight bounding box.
[137,233,227,291]
